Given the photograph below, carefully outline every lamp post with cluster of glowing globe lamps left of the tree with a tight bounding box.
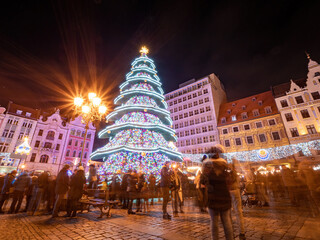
[74,92,107,166]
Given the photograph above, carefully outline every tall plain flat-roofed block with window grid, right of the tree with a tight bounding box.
[165,73,226,154]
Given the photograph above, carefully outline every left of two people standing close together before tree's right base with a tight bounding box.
[170,164,183,217]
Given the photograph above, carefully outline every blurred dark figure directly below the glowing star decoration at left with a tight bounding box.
[8,171,31,214]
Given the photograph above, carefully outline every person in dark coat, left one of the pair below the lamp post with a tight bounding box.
[52,164,70,217]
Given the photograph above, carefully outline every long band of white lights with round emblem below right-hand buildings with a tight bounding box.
[182,140,320,162]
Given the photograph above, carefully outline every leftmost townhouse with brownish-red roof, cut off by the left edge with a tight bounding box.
[0,102,40,173]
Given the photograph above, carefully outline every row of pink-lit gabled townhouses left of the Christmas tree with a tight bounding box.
[0,103,95,175]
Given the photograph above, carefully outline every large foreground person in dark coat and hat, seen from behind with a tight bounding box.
[200,144,233,240]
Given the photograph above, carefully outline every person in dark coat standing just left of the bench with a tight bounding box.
[67,166,86,217]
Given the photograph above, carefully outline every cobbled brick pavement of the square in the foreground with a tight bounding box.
[0,201,320,240]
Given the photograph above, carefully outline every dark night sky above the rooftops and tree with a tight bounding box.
[0,0,320,108]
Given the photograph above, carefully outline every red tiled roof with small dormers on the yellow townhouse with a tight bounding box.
[218,91,279,127]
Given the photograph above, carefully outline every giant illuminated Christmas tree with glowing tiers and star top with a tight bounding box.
[91,47,182,174]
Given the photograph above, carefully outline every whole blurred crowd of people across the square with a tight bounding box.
[0,145,320,240]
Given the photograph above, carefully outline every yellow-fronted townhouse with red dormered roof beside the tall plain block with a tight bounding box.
[218,91,289,164]
